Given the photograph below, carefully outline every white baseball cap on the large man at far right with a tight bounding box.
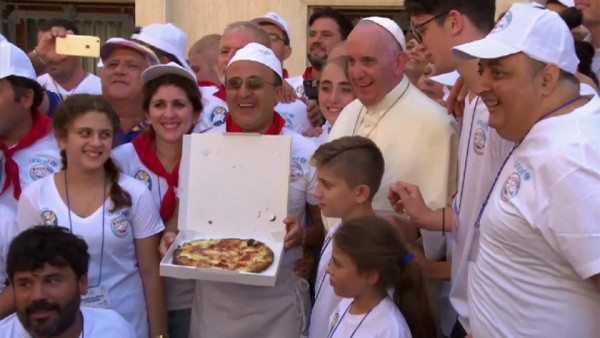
[452,3,579,74]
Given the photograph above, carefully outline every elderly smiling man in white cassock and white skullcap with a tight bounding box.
[329,17,457,266]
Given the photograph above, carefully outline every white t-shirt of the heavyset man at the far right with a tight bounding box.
[469,96,600,338]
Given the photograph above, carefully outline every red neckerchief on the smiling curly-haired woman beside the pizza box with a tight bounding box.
[131,130,180,222]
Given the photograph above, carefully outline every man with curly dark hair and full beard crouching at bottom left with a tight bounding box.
[0,226,135,338]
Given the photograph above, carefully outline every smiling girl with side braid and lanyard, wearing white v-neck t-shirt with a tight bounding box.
[17,94,166,338]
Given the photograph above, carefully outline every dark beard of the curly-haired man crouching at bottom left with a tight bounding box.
[17,294,81,337]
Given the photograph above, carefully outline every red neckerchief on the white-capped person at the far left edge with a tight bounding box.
[0,111,52,200]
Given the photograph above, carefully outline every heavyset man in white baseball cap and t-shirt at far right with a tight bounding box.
[453,4,600,338]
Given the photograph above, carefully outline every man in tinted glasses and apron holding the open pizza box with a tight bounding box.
[178,43,324,338]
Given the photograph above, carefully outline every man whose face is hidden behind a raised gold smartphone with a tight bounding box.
[37,19,102,95]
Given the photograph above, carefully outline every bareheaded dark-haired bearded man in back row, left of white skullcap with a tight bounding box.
[287,7,353,126]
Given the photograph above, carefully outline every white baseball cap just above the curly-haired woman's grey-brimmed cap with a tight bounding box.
[131,22,192,71]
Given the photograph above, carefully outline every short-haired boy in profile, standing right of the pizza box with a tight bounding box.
[308,136,384,338]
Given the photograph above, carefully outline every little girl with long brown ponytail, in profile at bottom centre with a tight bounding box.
[323,217,436,338]
